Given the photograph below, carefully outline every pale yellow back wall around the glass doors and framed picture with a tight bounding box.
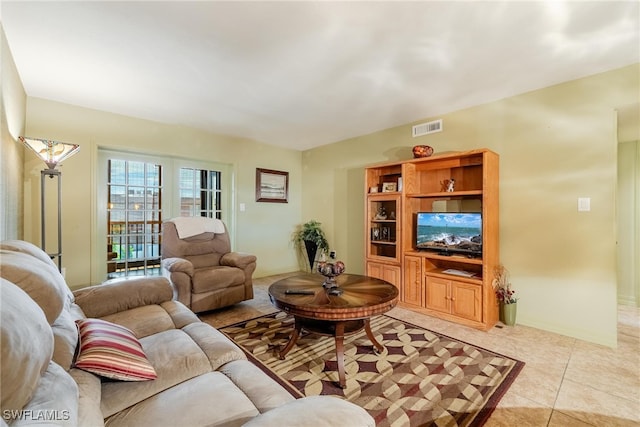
[24,98,301,288]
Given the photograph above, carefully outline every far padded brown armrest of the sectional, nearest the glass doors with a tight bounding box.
[73,276,173,317]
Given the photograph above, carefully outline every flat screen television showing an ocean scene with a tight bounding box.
[416,212,482,257]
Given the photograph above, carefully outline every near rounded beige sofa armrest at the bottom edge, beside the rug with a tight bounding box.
[243,396,376,427]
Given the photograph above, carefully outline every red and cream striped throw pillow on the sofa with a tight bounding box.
[75,319,157,381]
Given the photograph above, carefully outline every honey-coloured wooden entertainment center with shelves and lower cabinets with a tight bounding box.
[365,149,499,330]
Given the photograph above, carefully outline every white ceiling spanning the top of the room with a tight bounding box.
[0,0,640,150]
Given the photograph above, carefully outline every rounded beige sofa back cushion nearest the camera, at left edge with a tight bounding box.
[0,280,53,411]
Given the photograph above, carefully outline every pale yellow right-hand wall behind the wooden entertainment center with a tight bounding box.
[302,64,640,345]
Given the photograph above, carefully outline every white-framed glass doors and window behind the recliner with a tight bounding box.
[97,149,233,283]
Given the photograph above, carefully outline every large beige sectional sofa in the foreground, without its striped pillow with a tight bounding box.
[0,241,375,427]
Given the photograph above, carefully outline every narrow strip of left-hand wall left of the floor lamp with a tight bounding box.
[0,26,27,240]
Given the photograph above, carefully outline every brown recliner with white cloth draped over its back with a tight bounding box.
[162,217,256,313]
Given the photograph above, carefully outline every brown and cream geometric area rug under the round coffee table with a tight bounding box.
[220,312,524,427]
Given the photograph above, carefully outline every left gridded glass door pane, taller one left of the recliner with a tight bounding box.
[107,159,162,277]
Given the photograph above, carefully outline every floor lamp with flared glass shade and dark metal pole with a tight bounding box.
[18,136,80,272]
